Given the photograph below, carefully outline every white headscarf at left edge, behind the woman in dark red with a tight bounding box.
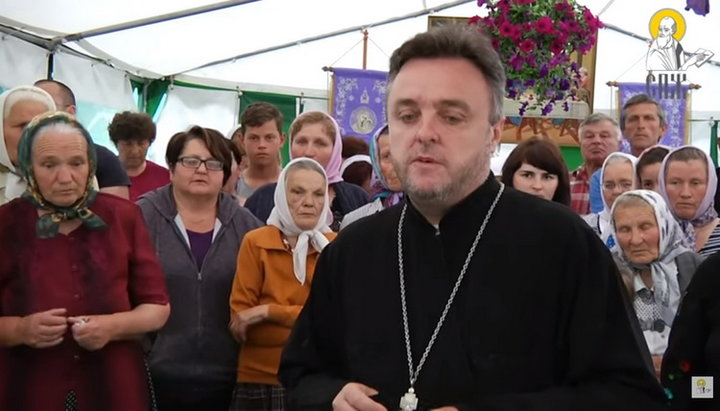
[0,86,55,204]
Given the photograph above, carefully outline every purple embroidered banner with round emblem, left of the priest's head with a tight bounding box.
[332,68,387,142]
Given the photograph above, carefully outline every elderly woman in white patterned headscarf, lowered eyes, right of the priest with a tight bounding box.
[611,190,702,377]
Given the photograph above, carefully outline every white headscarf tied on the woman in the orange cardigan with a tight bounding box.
[267,157,332,284]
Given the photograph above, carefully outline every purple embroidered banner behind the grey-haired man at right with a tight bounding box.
[618,83,688,153]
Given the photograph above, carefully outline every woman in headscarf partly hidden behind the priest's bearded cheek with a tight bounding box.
[340,124,403,229]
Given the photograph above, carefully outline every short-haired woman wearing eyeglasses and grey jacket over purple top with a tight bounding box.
[138,126,261,411]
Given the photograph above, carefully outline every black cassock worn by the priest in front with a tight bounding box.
[280,175,666,411]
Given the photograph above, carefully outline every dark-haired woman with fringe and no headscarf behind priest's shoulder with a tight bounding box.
[502,137,570,207]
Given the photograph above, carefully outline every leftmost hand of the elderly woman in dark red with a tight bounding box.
[18,308,67,348]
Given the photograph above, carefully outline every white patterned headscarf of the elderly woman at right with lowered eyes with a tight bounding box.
[611,190,693,325]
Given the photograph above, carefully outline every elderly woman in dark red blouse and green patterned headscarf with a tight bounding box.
[0,113,170,411]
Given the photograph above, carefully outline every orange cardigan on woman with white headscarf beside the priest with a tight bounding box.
[230,225,336,385]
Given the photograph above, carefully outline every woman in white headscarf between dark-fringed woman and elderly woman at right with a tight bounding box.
[583,152,637,248]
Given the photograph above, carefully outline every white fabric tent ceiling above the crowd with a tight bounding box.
[0,0,720,96]
